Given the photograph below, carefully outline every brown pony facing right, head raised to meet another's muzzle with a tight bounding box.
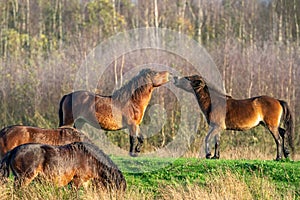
[59,69,170,156]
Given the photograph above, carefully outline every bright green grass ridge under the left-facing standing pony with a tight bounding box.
[113,158,300,198]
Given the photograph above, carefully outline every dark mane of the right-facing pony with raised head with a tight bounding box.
[112,69,154,103]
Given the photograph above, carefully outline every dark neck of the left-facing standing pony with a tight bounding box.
[194,86,211,124]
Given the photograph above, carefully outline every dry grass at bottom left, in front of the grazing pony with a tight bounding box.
[0,180,154,200]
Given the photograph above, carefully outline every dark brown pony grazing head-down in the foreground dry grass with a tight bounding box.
[0,142,126,190]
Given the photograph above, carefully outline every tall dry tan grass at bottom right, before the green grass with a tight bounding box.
[160,171,295,200]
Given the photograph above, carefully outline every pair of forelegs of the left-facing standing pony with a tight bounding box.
[205,126,220,158]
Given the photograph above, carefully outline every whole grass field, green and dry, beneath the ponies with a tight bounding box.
[0,157,300,200]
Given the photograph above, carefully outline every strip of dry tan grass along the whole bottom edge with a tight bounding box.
[0,171,295,200]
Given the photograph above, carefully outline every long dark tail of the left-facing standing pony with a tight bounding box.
[279,100,295,157]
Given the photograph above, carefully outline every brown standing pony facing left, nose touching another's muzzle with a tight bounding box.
[174,75,294,160]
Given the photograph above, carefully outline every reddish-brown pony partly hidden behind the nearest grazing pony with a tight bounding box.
[0,125,91,158]
